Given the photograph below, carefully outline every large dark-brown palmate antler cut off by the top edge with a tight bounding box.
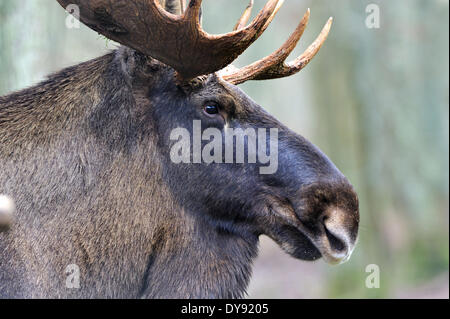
[57,0,283,80]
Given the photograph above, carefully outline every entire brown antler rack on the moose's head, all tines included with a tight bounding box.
[57,0,332,84]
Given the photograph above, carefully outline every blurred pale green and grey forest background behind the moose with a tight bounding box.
[0,0,449,298]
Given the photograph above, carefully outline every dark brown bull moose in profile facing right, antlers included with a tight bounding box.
[0,0,359,298]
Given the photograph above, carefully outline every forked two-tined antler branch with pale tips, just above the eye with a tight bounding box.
[222,9,333,84]
